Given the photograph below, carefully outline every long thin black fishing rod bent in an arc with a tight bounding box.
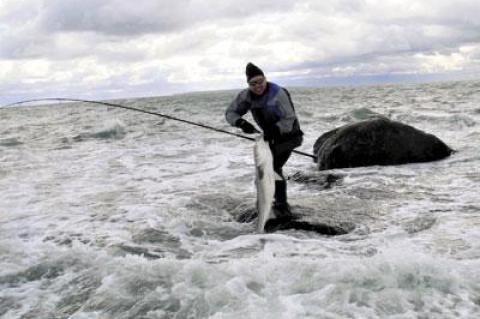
[2,97,317,160]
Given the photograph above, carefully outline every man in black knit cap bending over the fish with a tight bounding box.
[225,63,303,217]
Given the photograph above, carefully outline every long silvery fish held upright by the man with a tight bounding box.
[253,135,275,233]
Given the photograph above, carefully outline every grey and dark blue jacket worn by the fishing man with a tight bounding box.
[225,82,303,141]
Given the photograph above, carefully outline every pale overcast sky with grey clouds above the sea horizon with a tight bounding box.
[0,0,480,104]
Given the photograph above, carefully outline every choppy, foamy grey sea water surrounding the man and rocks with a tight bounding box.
[0,81,480,319]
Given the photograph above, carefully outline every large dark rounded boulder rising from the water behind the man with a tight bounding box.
[313,118,452,170]
